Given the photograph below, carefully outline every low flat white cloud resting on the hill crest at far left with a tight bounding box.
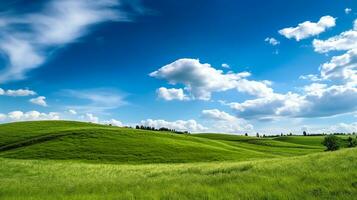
[7,111,60,121]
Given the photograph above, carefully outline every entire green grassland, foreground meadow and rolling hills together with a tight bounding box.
[0,121,357,199]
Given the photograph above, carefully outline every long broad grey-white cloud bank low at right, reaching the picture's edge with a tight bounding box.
[226,83,357,120]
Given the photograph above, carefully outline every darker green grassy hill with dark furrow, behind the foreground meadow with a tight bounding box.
[0,121,323,163]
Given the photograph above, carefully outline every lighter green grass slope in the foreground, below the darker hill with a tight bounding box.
[0,148,357,200]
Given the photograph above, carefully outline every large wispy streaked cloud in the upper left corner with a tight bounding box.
[0,0,140,82]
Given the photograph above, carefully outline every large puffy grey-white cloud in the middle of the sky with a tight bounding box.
[150,58,273,100]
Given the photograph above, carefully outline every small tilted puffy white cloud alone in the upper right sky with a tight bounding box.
[279,16,336,41]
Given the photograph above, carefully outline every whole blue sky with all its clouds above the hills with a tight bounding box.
[0,0,357,134]
